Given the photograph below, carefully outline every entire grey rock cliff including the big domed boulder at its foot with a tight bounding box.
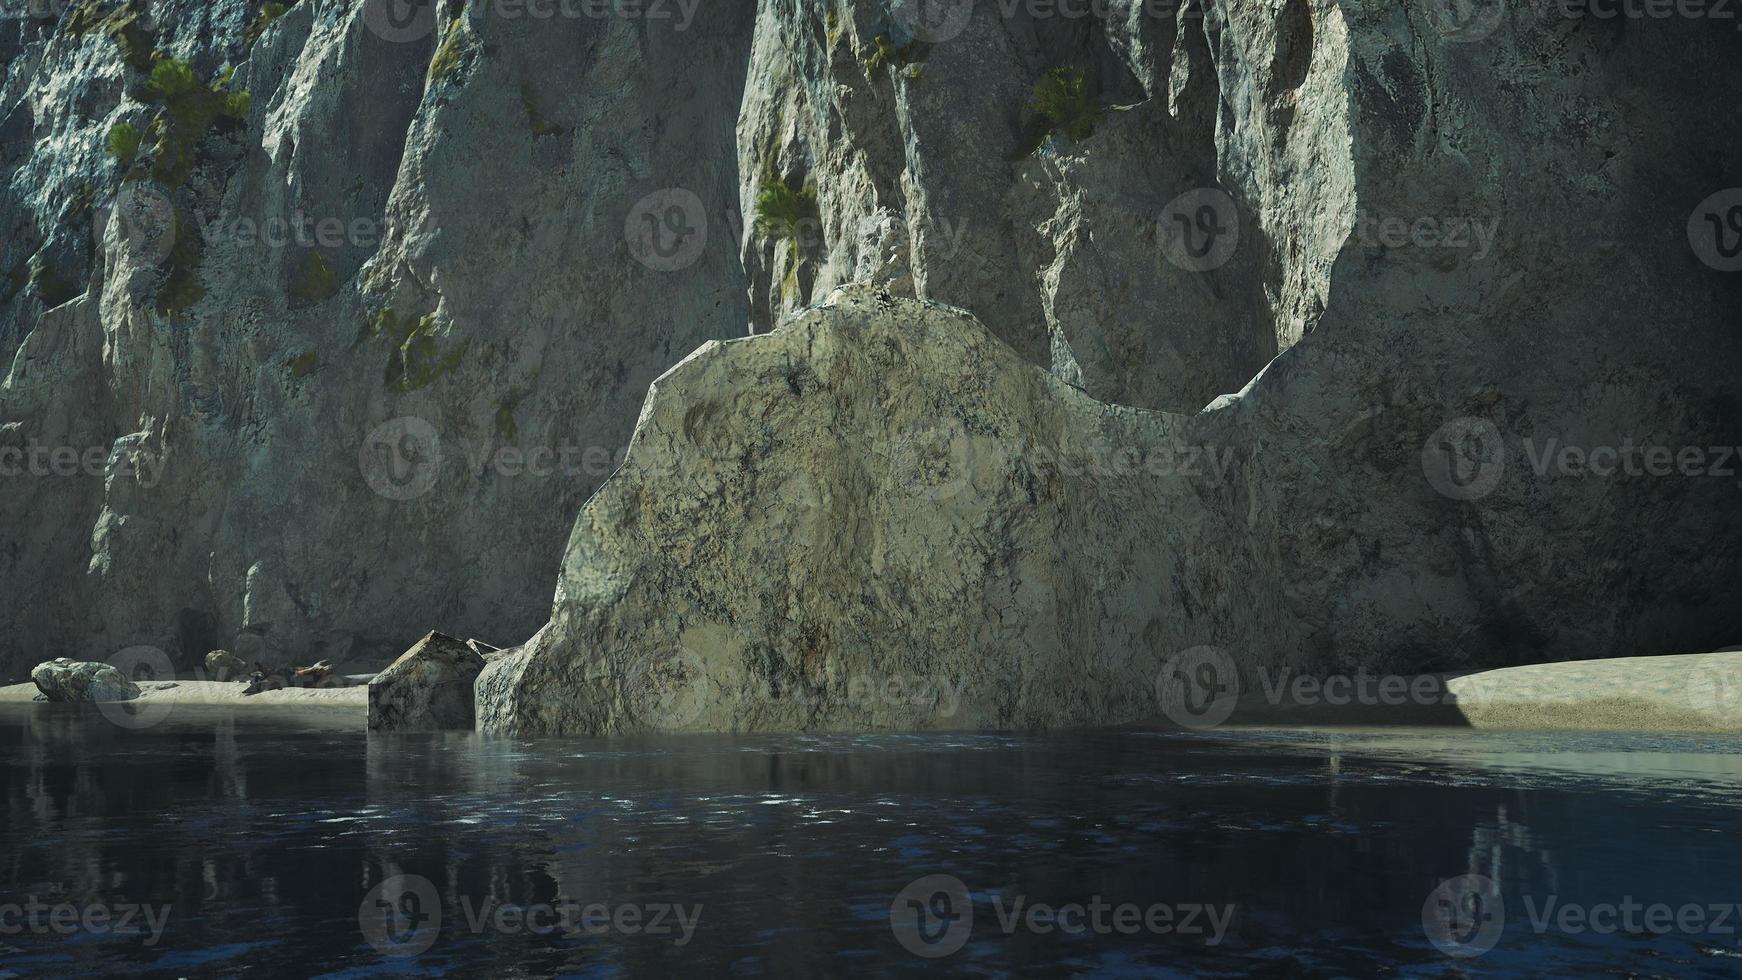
[0,0,1742,731]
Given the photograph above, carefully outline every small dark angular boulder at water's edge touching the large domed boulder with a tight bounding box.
[369,632,484,731]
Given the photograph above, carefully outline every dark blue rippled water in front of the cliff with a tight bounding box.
[0,705,1742,977]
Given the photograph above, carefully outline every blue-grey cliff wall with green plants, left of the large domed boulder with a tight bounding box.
[0,0,753,668]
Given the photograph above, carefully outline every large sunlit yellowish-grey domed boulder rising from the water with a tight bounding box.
[477,289,1240,733]
